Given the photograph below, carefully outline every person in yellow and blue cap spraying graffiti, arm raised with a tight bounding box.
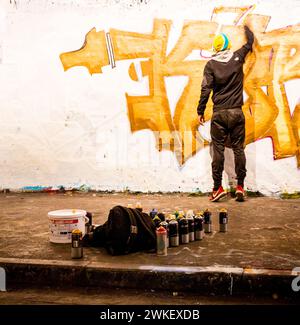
[197,26,254,202]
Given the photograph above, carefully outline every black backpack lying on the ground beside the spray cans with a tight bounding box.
[92,205,156,255]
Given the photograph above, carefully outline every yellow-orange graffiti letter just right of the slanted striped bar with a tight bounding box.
[110,20,176,158]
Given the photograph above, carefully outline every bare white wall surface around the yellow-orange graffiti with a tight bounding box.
[0,0,300,194]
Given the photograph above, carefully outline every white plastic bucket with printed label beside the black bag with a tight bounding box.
[48,209,89,244]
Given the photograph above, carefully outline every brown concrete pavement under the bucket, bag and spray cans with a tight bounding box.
[0,193,300,270]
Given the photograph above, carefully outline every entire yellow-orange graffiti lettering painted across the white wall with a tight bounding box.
[60,7,300,167]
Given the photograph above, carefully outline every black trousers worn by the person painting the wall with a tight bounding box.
[210,108,246,189]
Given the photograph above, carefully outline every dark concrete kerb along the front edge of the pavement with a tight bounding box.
[0,258,300,299]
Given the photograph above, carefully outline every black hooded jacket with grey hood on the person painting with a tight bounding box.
[197,26,254,115]
